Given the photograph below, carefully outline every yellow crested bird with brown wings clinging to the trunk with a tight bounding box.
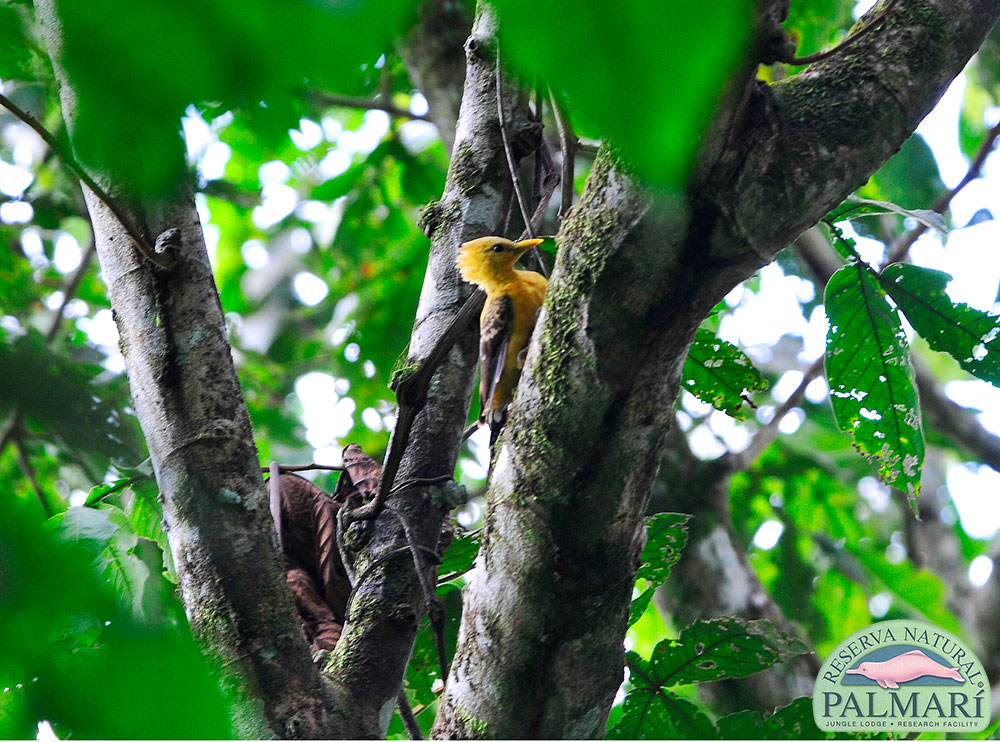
[458,237,548,447]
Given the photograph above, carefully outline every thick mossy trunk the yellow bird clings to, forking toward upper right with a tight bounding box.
[434,0,1000,738]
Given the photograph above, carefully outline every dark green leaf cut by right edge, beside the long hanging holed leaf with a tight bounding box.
[881,263,1000,385]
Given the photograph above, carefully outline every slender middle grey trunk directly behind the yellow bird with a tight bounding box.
[328,8,538,737]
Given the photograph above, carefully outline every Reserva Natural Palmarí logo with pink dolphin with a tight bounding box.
[813,621,991,733]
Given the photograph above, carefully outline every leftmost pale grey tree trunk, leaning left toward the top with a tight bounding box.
[36,0,338,738]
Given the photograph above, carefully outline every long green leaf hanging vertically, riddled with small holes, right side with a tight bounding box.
[826,262,924,508]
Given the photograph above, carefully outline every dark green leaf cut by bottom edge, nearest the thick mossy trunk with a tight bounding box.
[607,680,716,739]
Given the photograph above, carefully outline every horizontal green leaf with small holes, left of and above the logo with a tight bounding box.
[629,618,810,687]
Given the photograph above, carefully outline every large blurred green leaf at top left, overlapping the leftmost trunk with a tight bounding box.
[49,0,415,192]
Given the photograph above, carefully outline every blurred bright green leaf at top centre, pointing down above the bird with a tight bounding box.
[495,0,751,187]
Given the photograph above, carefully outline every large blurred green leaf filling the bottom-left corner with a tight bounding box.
[0,500,231,739]
